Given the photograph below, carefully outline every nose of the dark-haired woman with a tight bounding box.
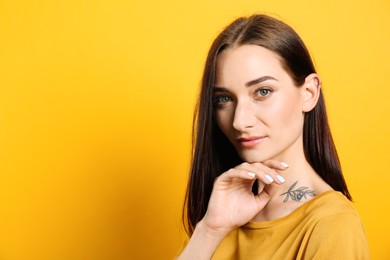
[233,101,257,131]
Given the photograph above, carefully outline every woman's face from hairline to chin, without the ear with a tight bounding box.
[214,45,306,162]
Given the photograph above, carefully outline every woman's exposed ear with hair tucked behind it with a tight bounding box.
[301,73,321,112]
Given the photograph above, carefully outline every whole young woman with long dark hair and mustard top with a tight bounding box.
[178,15,369,259]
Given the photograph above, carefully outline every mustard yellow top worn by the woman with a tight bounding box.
[212,190,369,260]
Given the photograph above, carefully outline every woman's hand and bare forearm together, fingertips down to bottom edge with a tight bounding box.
[177,160,288,259]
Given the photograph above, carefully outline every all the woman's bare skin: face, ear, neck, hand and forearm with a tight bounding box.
[178,45,331,259]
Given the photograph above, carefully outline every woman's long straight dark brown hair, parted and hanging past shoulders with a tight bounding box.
[183,15,352,235]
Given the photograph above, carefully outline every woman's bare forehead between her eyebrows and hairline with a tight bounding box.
[217,45,289,85]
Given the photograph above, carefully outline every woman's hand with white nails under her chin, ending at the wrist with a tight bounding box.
[202,160,288,236]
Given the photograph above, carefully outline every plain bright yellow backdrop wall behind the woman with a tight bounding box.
[0,0,390,260]
